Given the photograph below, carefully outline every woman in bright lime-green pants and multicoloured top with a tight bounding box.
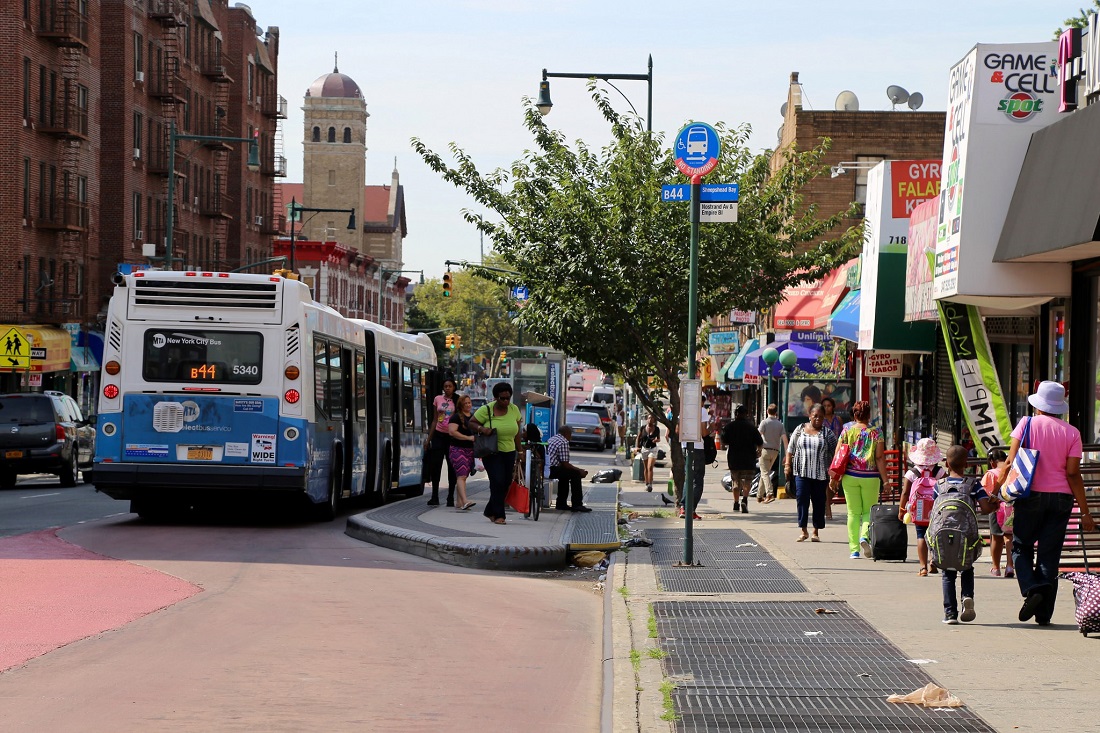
[831,400,887,560]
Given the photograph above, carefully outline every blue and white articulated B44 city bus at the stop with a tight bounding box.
[95,271,436,518]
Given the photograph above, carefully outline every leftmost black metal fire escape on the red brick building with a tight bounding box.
[34,0,89,318]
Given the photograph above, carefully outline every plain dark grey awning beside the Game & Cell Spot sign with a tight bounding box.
[993,98,1100,262]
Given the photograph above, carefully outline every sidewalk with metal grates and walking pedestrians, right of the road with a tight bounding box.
[607,468,1100,732]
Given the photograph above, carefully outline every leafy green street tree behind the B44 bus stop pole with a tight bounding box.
[413,86,861,485]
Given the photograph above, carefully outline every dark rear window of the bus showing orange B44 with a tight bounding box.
[142,328,264,384]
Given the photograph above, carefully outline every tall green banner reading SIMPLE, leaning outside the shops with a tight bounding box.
[936,300,1012,457]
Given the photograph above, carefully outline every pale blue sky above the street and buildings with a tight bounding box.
[255,0,1064,277]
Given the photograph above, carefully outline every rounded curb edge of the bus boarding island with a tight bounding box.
[344,508,569,571]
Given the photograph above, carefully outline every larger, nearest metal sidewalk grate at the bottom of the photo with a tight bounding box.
[653,601,993,733]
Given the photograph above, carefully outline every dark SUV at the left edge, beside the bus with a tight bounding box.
[0,391,96,489]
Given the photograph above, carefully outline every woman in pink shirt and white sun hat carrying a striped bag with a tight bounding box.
[998,382,1096,626]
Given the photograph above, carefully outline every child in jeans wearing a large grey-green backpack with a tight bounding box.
[925,446,996,624]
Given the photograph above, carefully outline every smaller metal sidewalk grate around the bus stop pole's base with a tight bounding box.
[646,528,806,593]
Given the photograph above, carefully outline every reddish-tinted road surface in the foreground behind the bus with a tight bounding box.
[0,471,609,733]
